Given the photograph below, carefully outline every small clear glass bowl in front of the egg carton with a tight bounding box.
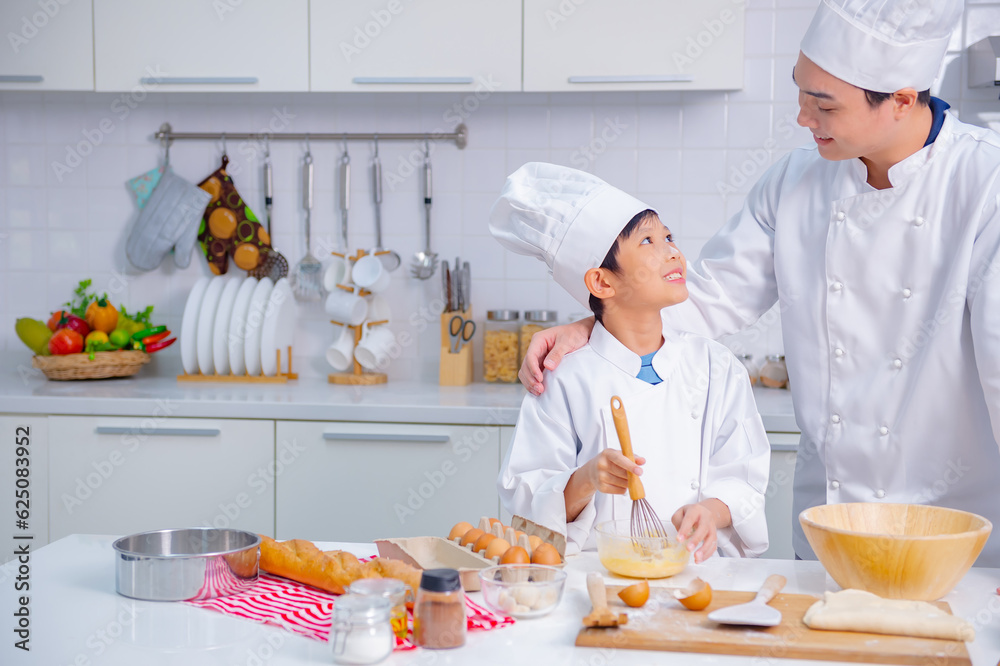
[479,564,566,619]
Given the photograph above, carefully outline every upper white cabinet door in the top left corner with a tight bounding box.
[0,0,94,90]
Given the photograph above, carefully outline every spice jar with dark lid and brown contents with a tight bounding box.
[413,569,466,648]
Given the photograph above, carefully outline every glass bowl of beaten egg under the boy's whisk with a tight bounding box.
[595,519,691,578]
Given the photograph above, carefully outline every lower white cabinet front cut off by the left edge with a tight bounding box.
[0,414,49,563]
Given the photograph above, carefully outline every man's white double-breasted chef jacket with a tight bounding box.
[663,115,1000,567]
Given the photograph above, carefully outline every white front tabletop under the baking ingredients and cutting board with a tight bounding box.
[0,535,1000,666]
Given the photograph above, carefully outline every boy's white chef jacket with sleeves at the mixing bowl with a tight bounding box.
[497,324,770,556]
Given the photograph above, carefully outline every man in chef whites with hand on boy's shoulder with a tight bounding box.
[521,0,1000,567]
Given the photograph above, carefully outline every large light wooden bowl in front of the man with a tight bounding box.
[799,502,993,601]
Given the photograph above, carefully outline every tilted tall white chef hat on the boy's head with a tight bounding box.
[490,162,649,307]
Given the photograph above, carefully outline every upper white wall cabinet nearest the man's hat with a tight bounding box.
[524,0,744,91]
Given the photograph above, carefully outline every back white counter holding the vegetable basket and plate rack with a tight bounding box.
[0,351,799,432]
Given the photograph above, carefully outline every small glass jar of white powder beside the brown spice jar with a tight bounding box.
[330,594,396,664]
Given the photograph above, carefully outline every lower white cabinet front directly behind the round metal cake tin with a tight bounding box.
[49,416,275,541]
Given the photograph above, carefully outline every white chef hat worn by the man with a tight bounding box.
[801,0,963,93]
